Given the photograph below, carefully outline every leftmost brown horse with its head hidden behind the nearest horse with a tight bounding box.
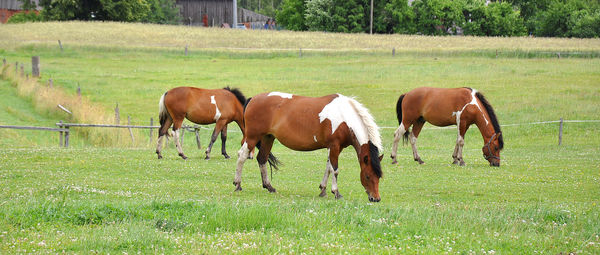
[156,87,246,159]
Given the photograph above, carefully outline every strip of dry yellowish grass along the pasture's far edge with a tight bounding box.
[0,21,600,52]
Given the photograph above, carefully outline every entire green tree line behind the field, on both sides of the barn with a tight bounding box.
[9,0,600,38]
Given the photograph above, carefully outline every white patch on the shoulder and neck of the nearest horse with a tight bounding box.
[319,94,369,145]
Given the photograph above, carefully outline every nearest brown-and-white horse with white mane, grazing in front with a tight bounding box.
[233,92,382,202]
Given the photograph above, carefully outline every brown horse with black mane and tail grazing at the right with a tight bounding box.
[392,87,504,166]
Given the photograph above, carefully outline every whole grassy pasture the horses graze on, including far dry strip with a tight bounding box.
[0,22,600,254]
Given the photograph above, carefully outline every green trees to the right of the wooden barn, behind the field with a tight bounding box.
[276,0,600,38]
